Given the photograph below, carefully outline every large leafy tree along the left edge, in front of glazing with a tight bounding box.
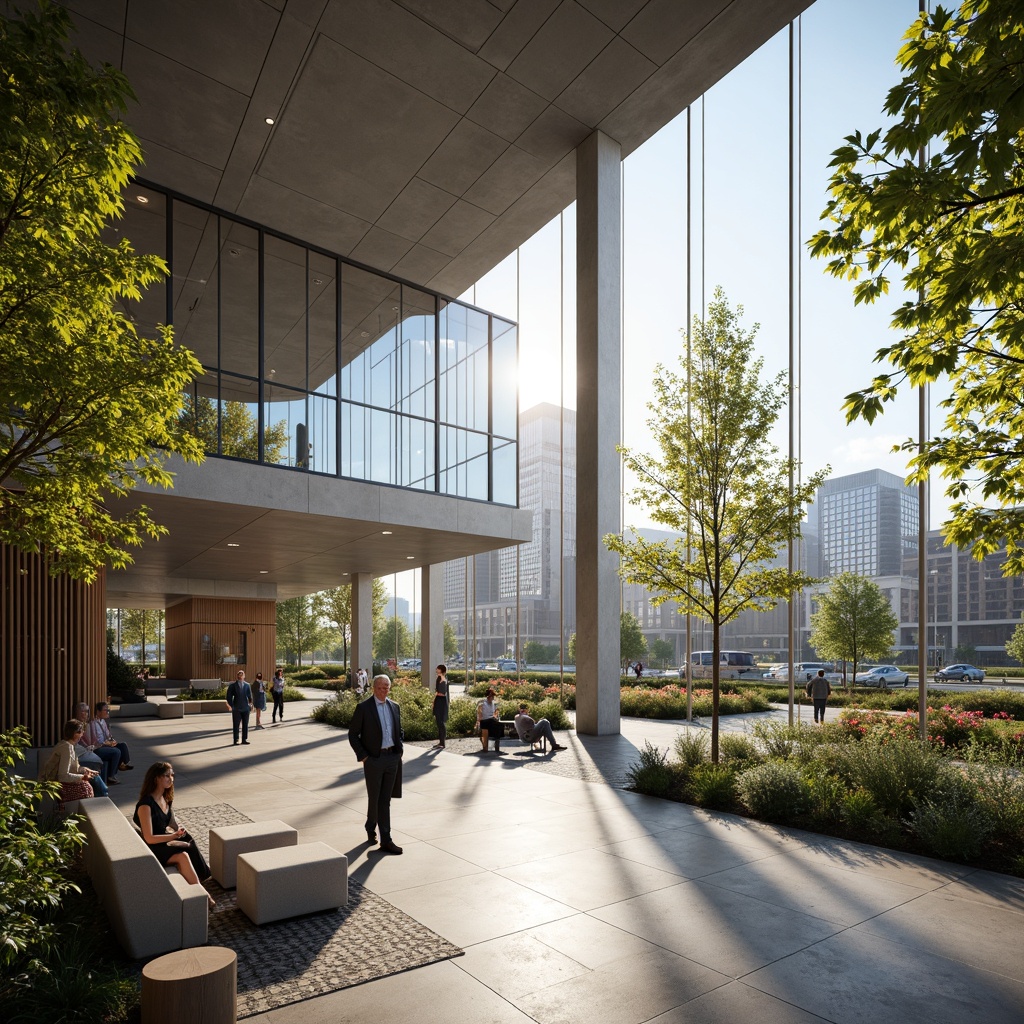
[0,3,202,581]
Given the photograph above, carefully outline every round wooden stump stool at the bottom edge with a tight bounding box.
[142,946,238,1024]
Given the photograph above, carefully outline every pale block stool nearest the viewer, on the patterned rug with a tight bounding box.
[238,843,348,925]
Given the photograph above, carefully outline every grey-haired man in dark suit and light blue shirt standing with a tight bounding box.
[348,676,402,853]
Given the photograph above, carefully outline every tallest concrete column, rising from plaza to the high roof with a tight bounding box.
[577,131,622,736]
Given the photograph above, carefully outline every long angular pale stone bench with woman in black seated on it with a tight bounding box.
[79,797,209,959]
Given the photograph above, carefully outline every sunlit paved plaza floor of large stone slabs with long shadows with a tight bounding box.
[111,703,1024,1024]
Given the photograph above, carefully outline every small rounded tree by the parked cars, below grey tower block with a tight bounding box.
[810,572,899,678]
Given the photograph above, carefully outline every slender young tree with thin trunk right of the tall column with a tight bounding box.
[604,289,825,762]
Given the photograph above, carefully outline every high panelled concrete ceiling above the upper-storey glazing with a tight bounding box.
[68,0,811,303]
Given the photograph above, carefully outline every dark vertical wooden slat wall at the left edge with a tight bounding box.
[0,545,106,746]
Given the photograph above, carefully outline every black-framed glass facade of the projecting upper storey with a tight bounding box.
[110,184,518,506]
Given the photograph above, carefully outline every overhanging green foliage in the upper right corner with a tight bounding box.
[810,0,1024,575]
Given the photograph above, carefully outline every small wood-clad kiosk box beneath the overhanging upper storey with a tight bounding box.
[165,597,278,682]
